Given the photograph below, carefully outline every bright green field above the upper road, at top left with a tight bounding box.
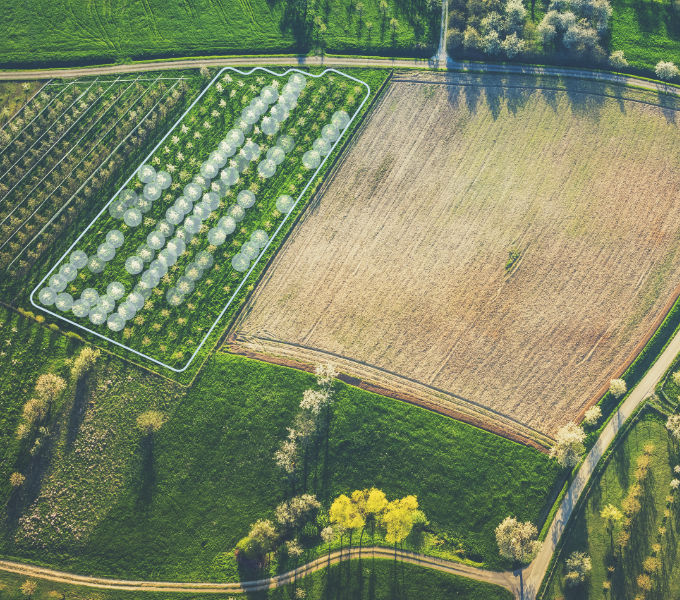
[0,0,439,65]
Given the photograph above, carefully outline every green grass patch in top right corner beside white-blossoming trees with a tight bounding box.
[610,0,680,72]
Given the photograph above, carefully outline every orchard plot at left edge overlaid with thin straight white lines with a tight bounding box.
[0,75,187,275]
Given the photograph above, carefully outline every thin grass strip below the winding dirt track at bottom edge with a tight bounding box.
[0,559,512,600]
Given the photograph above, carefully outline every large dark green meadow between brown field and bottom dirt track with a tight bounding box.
[0,314,559,580]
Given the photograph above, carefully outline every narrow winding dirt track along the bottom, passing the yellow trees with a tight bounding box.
[0,546,517,594]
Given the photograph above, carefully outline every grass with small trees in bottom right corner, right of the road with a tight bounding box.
[543,411,680,600]
